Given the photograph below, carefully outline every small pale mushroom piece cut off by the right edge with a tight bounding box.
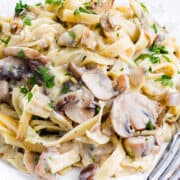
[166,92,180,106]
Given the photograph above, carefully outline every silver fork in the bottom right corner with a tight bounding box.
[147,131,180,180]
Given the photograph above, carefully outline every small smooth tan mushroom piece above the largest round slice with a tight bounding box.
[129,68,145,88]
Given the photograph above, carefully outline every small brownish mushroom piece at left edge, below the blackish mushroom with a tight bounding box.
[0,81,10,102]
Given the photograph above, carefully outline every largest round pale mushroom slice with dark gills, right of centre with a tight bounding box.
[111,93,159,137]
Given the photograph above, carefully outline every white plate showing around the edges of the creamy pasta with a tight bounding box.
[0,0,180,180]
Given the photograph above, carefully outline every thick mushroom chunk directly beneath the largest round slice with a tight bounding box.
[124,136,155,157]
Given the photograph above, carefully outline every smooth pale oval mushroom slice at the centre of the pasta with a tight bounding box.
[82,69,117,100]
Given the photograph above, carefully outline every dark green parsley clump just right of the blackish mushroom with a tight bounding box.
[37,67,55,88]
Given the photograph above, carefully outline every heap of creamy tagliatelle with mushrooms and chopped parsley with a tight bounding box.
[0,0,180,180]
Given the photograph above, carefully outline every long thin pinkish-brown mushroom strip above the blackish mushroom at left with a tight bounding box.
[3,47,50,64]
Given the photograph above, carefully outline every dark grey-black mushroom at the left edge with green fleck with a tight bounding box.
[0,57,28,81]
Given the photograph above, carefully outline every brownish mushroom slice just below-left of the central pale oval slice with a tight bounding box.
[65,88,95,123]
